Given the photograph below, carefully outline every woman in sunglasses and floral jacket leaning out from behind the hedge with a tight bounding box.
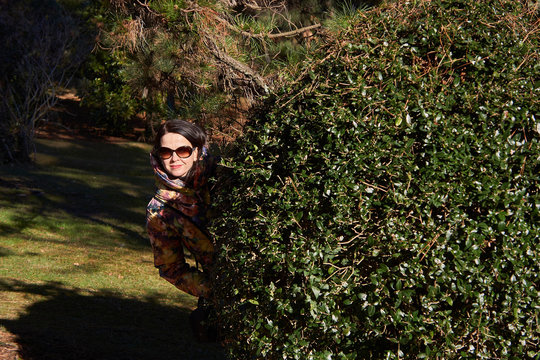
[146,120,216,335]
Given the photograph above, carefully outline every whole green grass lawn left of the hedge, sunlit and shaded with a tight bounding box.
[0,139,225,359]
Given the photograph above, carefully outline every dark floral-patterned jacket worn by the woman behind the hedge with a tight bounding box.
[146,148,216,298]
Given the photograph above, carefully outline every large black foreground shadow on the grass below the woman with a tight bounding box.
[0,281,226,360]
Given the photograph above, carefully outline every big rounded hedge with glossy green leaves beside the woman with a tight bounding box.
[211,0,540,359]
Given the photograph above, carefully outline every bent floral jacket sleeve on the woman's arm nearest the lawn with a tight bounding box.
[146,210,211,297]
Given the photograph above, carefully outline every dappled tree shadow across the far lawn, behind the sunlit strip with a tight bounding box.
[0,140,154,247]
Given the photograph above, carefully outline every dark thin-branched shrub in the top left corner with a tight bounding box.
[0,0,90,163]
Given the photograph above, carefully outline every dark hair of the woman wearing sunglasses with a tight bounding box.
[152,119,206,184]
